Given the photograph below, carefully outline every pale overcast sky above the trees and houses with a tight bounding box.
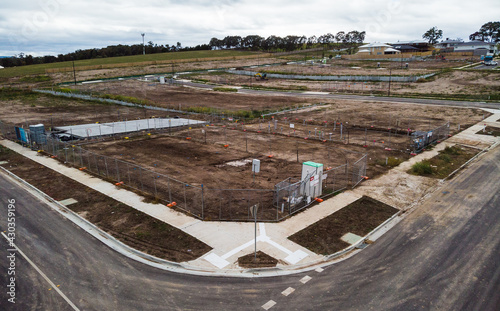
[0,0,500,56]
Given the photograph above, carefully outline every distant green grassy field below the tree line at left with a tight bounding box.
[0,50,255,78]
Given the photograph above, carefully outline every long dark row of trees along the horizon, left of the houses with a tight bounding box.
[0,31,365,67]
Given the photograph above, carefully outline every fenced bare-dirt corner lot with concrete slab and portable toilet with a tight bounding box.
[1,86,484,221]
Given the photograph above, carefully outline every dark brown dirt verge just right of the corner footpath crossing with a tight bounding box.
[289,196,398,255]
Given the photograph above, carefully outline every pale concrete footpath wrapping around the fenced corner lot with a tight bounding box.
[0,110,500,276]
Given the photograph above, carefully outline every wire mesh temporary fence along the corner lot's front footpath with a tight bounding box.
[2,123,366,221]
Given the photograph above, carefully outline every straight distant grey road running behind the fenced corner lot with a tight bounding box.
[177,81,500,109]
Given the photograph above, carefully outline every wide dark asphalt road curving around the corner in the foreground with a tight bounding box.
[0,147,500,311]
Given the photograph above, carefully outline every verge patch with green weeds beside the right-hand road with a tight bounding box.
[408,146,478,179]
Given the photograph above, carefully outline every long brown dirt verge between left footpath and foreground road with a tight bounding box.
[0,147,211,262]
